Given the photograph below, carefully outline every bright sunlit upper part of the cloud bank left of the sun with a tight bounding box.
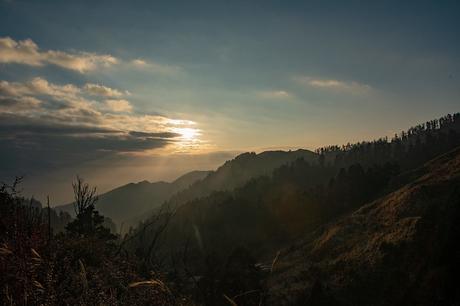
[0,77,194,133]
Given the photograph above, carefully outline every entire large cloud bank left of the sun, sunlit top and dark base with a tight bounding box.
[0,77,198,175]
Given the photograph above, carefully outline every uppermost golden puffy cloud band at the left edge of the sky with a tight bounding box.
[0,37,119,73]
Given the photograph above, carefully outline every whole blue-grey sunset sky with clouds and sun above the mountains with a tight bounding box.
[0,0,460,204]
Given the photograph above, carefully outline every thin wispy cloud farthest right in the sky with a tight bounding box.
[294,76,372,94]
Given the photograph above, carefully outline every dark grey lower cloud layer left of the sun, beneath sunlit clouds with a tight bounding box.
[0,114,175,180]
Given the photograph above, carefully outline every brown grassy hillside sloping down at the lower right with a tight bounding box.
[268,148,460,305]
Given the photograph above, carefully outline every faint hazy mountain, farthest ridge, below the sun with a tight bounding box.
[55,171,210,224]
